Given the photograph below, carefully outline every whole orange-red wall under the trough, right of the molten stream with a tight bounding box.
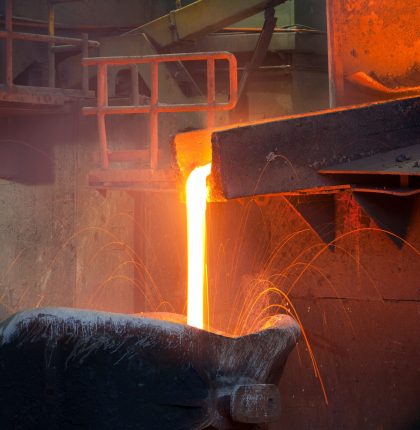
[205,192,420,430]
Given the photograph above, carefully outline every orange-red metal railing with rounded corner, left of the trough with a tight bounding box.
[82,52,238,170]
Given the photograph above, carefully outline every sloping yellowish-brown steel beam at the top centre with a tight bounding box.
[126,0,285,48]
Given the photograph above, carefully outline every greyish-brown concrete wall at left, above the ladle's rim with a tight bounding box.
[0,111,135,317]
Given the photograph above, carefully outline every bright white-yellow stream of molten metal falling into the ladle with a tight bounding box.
[186,164,211,328]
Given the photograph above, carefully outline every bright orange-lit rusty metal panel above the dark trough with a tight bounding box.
[327,0,420,105]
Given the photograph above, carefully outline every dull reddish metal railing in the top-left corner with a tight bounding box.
[0,0,99,93]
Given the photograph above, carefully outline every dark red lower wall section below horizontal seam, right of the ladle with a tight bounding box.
[271,298,420,430]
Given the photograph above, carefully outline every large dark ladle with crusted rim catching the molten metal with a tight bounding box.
[0,308,300,430]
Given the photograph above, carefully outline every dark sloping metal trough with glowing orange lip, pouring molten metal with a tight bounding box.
[175,97,420,200]
